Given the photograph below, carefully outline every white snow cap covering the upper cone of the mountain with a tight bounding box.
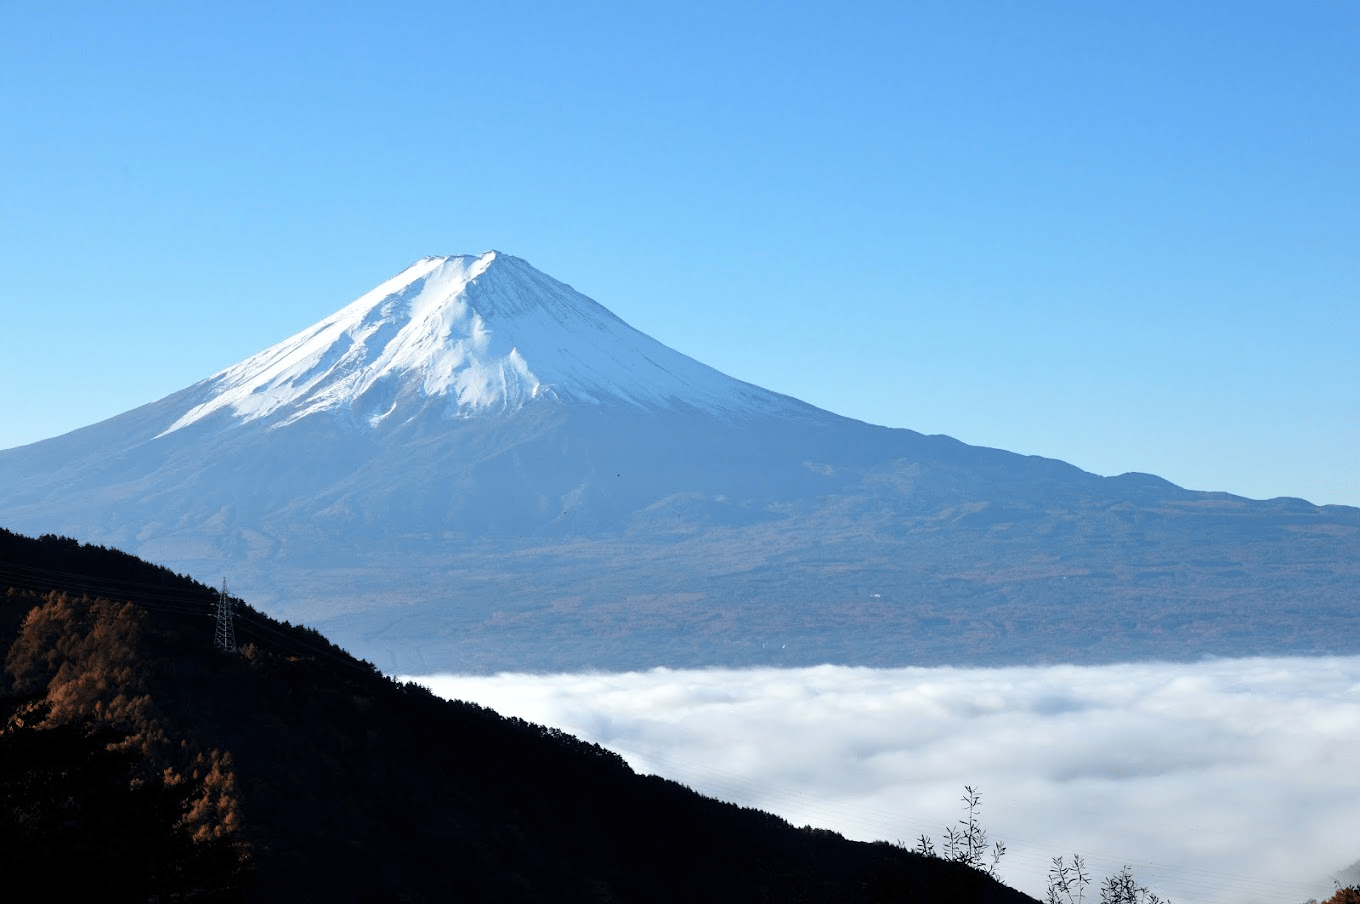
[162,251,806,435]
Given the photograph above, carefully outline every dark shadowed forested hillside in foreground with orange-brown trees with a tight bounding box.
[0,532,1032,901]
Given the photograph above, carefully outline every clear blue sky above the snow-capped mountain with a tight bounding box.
[0,0,1360,504]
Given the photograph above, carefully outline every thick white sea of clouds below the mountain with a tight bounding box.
[413,657,1360,904]
